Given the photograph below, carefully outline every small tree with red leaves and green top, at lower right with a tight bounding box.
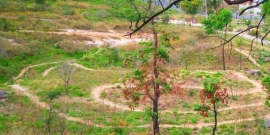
[194,78,229,135]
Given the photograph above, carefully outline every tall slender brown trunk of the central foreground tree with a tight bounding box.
[152,28,160,135]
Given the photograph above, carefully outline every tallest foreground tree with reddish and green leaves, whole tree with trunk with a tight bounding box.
[123,25,182,135]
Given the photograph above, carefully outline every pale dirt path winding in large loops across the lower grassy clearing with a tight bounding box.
[11,61,264,128]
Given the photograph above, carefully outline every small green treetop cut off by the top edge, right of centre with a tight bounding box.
[180,0,202,20]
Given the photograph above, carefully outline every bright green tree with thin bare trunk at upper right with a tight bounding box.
[202,9,232,70]
